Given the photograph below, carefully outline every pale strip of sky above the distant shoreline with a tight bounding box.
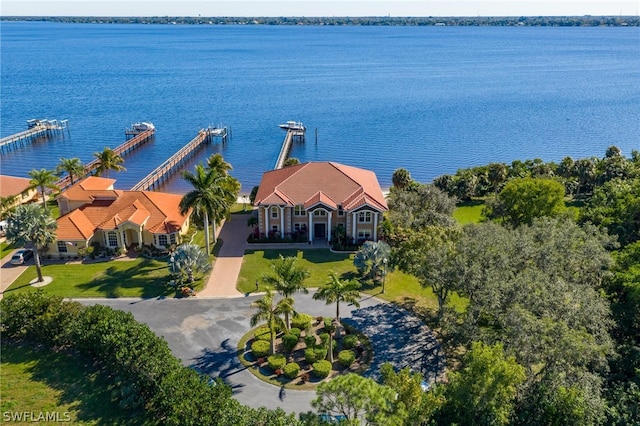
[0,0,640,17]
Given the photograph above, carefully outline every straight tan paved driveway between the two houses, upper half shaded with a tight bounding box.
[198,213,251,297]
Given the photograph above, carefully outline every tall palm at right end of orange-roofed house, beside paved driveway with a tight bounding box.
[180,164,217,255]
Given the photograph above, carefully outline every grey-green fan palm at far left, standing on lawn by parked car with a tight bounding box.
[7,203,58,282]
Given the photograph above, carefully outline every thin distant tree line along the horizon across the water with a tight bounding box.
[0,15,640,27]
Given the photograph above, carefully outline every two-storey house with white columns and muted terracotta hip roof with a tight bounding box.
[254,162,388,242]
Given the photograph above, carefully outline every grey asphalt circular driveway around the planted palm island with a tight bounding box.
[78,290,444,414]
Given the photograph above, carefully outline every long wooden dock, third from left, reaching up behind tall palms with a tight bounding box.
[131,127,220,191]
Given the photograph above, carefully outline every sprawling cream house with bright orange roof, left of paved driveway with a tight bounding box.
[49,176,190,257]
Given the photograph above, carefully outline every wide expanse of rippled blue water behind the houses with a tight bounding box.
[0,22,640,193]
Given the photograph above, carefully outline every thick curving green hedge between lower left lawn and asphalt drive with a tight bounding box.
[0,291,299,426]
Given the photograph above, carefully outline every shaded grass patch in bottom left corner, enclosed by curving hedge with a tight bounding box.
[0,341,144,425]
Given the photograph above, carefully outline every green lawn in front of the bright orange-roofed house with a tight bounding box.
[5,259,178,298]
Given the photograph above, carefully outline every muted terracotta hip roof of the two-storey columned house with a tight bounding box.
[255,162,388,211]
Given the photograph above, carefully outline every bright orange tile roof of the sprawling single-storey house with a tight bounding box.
[57,185,191,241]
